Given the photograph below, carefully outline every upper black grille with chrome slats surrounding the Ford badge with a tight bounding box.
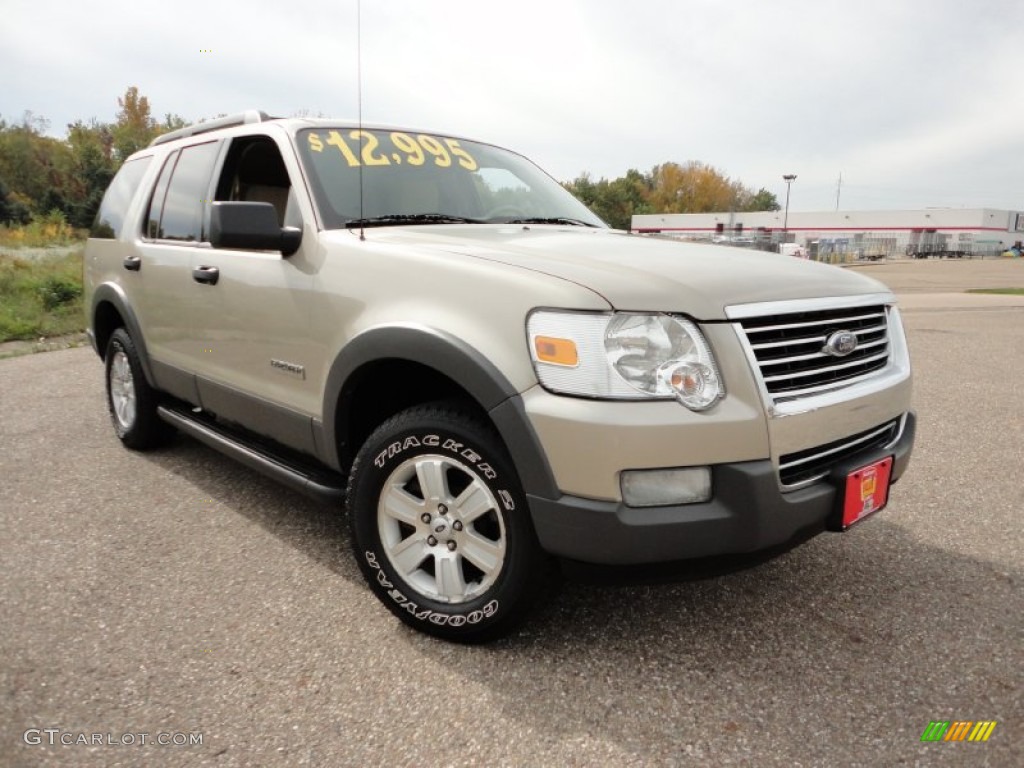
[739,304,889,402]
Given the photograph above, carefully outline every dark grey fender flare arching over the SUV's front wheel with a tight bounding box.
[315,325,559,499]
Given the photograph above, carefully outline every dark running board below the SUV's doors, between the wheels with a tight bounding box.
[157,406,346,506]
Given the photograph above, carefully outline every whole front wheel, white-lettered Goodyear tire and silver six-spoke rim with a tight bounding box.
[347,404,548,642]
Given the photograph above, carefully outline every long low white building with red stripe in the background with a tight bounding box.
[632,208,1024,260]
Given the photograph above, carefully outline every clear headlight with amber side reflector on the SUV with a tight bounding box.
[526,310,725,411]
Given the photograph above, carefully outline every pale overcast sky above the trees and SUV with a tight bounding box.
[6,0,1024,211]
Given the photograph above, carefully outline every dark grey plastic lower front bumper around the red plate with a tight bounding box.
[528,412,915,565]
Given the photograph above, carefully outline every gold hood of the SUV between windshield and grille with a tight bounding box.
[350,224,890,321]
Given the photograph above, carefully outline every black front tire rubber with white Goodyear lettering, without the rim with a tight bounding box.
[348,409,540,642]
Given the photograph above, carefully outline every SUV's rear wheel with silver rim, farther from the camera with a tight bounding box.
[103,328,174,451]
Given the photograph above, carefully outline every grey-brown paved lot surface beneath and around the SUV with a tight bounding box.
[0,263,1024,766]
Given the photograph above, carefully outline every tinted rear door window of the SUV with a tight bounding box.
[146,141,219,243]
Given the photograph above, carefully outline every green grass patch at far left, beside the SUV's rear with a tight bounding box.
[0,248,85,342]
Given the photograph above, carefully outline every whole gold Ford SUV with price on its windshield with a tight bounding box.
[85,112,914,642]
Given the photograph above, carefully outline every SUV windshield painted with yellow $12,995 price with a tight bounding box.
[297,126,605,229]
